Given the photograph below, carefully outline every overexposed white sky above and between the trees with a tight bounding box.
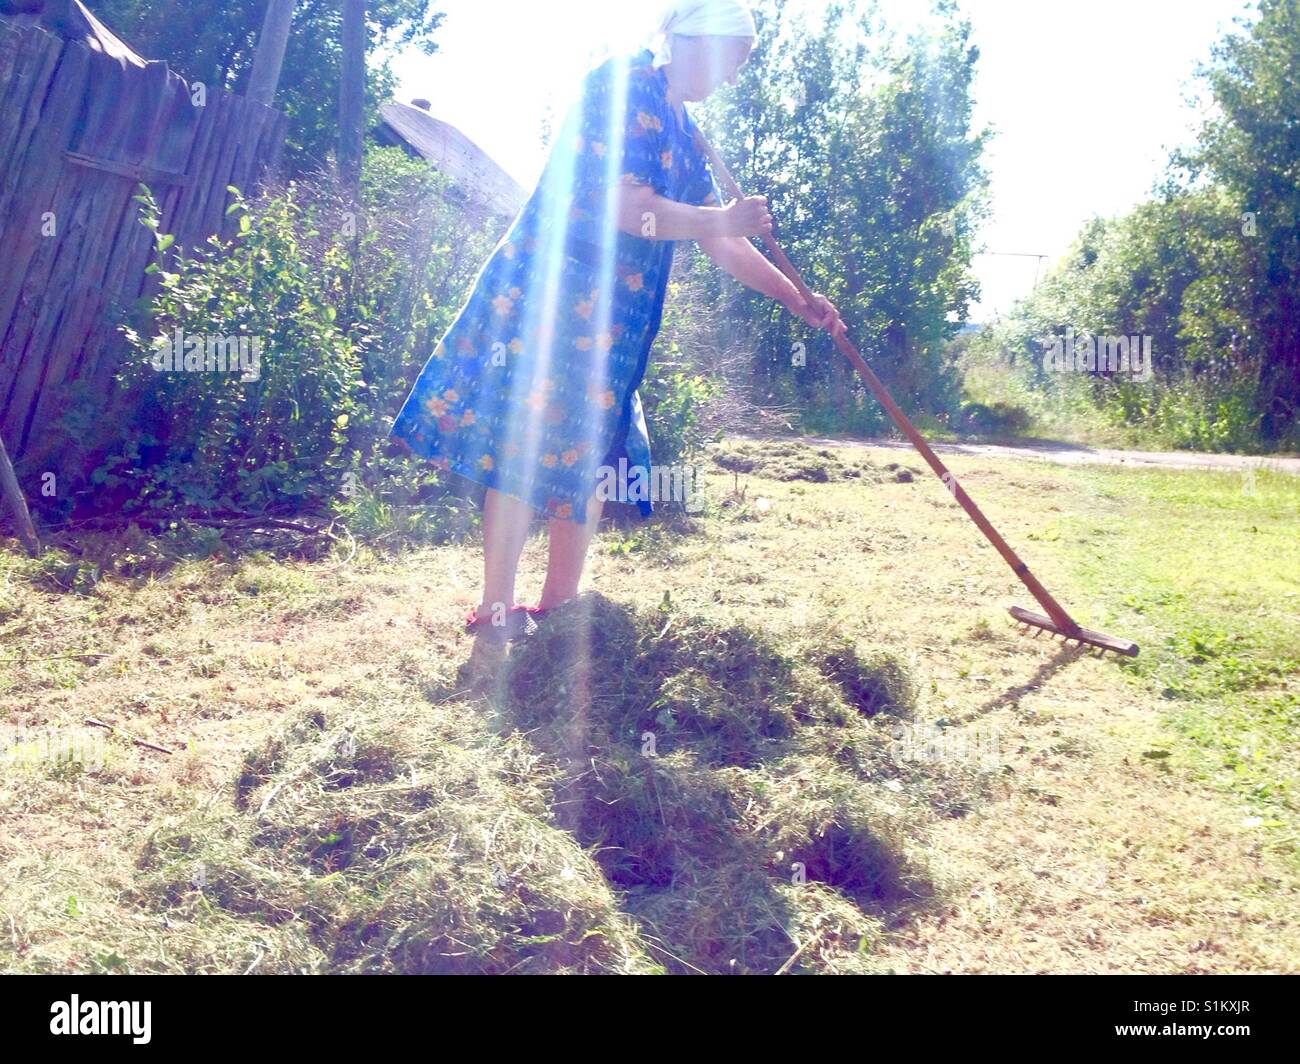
[394,0,1248,323]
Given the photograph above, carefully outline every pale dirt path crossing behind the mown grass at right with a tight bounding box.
[736,436,1300,476]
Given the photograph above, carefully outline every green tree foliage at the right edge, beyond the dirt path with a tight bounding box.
[980,0,1300,450]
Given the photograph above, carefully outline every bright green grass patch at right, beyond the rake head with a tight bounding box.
[1058,470,1300,856]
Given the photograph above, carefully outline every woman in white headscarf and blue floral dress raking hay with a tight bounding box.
[393,0,844,635]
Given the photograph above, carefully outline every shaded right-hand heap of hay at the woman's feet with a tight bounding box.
[488,596,924,972]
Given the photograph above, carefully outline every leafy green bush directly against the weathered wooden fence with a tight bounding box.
[105,187,360,511]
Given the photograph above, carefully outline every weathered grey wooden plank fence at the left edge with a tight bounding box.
[0,18,285,470]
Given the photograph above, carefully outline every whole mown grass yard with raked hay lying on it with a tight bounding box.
[0,446,1300,973]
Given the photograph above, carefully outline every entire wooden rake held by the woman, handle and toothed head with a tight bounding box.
[696,130,1138,658]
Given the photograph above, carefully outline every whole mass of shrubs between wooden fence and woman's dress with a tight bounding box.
[92,148,491,537]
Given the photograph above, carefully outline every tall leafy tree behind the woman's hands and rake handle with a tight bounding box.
[706,0,987,428]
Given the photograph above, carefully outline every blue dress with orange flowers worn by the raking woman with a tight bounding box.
[391,52,720,522]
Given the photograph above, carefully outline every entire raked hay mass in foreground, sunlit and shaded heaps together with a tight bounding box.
[139,596,967,973]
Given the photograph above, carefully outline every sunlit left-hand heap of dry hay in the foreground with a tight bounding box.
[139,698,653,973]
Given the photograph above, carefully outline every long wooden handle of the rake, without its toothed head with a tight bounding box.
[696,130,1079,632]
